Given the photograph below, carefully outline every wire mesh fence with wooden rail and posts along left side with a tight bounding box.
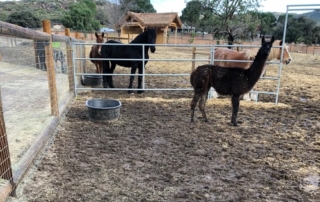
[0,22,81,199]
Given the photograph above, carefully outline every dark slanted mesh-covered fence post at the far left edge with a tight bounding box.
[0,89,16,196]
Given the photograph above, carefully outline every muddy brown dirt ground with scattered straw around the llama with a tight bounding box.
[8,48,320,202]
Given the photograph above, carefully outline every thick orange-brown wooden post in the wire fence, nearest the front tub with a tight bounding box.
[42,20,59,116]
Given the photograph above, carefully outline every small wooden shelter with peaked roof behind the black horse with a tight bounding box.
[115,11,182,44]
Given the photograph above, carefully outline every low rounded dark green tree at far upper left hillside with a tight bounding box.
[7,11,41,28]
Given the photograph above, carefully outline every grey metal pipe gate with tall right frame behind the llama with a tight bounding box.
[72,4,320,104]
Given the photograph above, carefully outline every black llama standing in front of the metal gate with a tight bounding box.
[190,36,274,126]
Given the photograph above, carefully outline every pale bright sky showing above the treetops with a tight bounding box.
[150,0,320,15]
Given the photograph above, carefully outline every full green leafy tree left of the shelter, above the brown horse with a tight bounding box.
[61,0,100,31]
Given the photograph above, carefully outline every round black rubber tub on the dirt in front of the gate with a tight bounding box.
[86,99,121,122]
